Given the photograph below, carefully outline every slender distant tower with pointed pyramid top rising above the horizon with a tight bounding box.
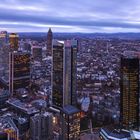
[47,28,53,55]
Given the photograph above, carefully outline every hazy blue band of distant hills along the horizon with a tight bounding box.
[13,32,140,40]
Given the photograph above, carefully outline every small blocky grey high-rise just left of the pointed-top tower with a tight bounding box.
[32,46,42,61]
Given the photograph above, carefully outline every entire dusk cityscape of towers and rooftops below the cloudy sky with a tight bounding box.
[0,25,140,140]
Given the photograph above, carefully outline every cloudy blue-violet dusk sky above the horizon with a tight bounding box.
[0,0,140,33]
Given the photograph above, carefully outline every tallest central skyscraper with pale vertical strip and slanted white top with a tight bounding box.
[52,40,77,108]
